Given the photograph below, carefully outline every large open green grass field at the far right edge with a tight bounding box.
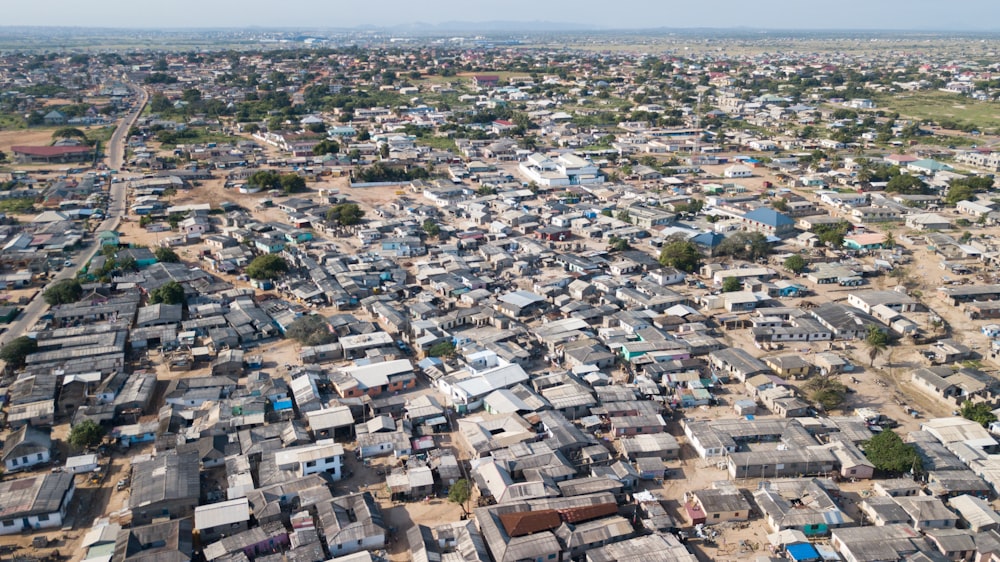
[876,91,1000,128]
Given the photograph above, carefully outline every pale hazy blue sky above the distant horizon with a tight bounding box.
[0,0,1000,31]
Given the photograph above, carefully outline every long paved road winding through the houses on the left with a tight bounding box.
[0,86,149,345]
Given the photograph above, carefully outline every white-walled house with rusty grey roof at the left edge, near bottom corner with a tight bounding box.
[0,472,76,535]
